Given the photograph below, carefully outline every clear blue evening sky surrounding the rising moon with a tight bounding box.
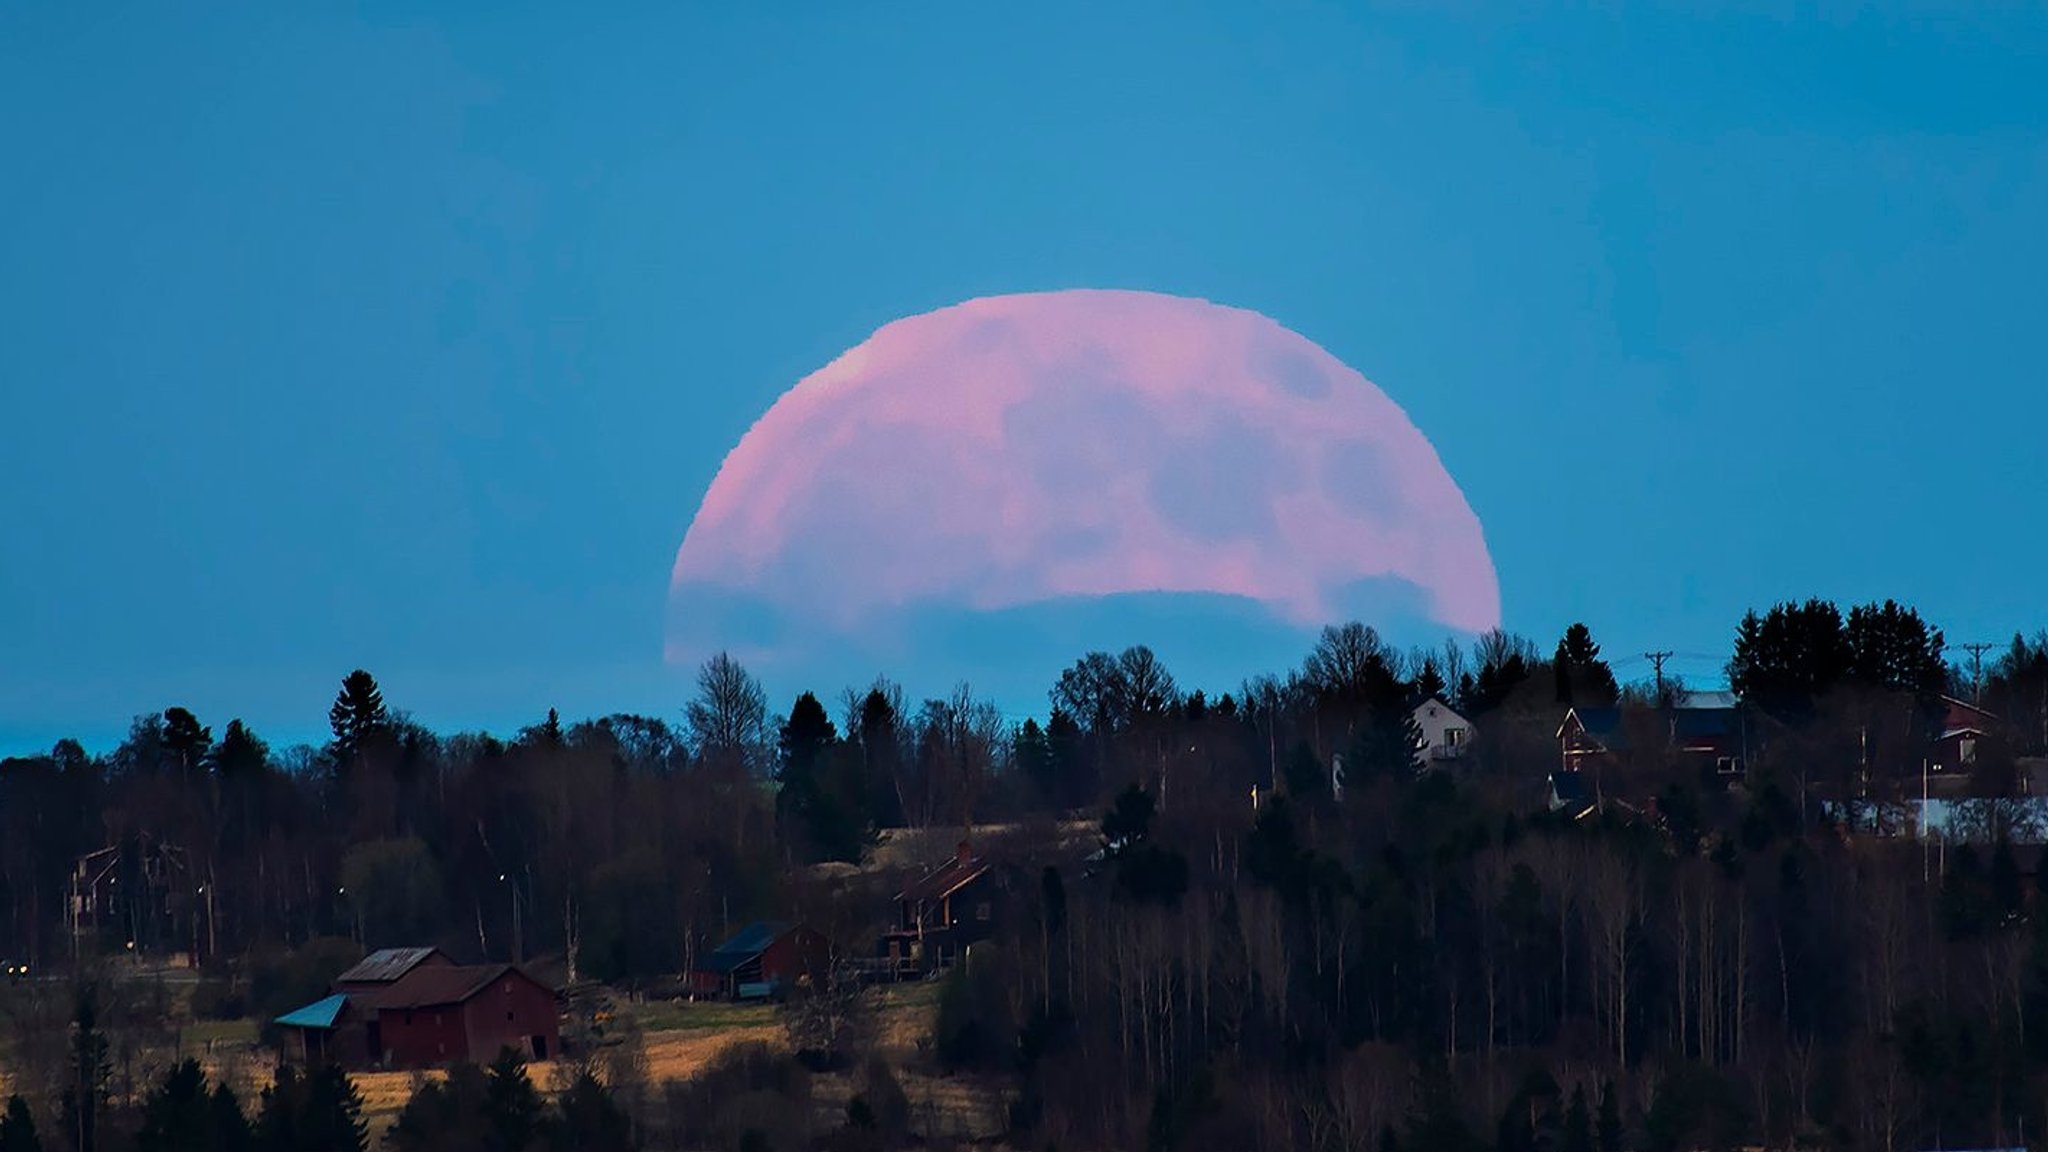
[0,4,2048,752]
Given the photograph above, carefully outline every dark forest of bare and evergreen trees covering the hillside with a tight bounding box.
[0,601,2048,1152]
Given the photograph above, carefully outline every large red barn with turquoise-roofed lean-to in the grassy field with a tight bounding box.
[276,947,561,1068]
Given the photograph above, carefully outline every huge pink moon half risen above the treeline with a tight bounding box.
[670,289,1501,660]
